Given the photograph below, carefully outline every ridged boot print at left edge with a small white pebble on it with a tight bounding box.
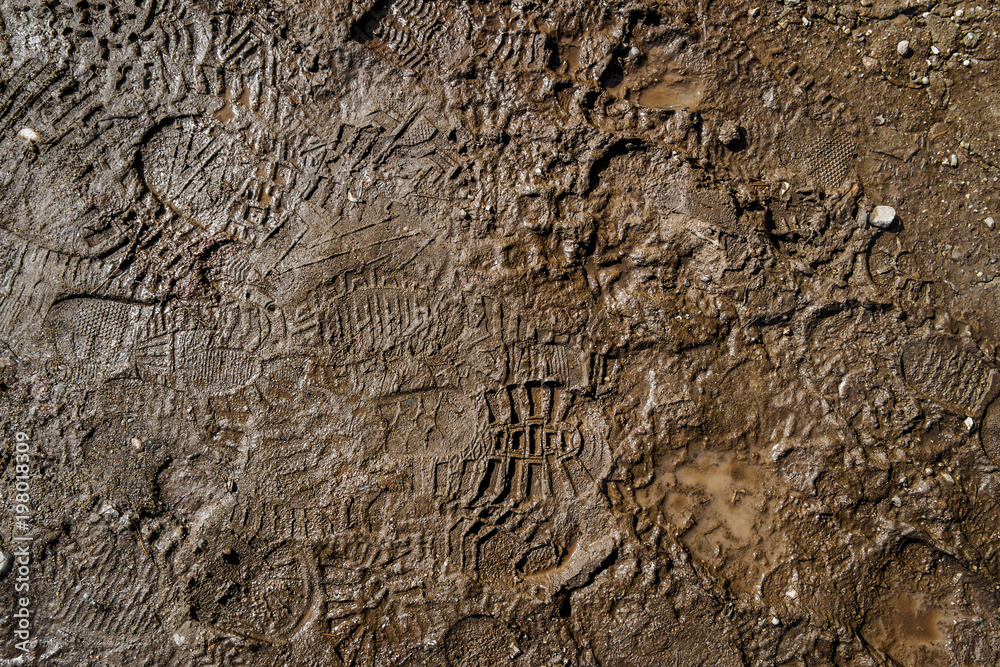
[0,60,152,257]
